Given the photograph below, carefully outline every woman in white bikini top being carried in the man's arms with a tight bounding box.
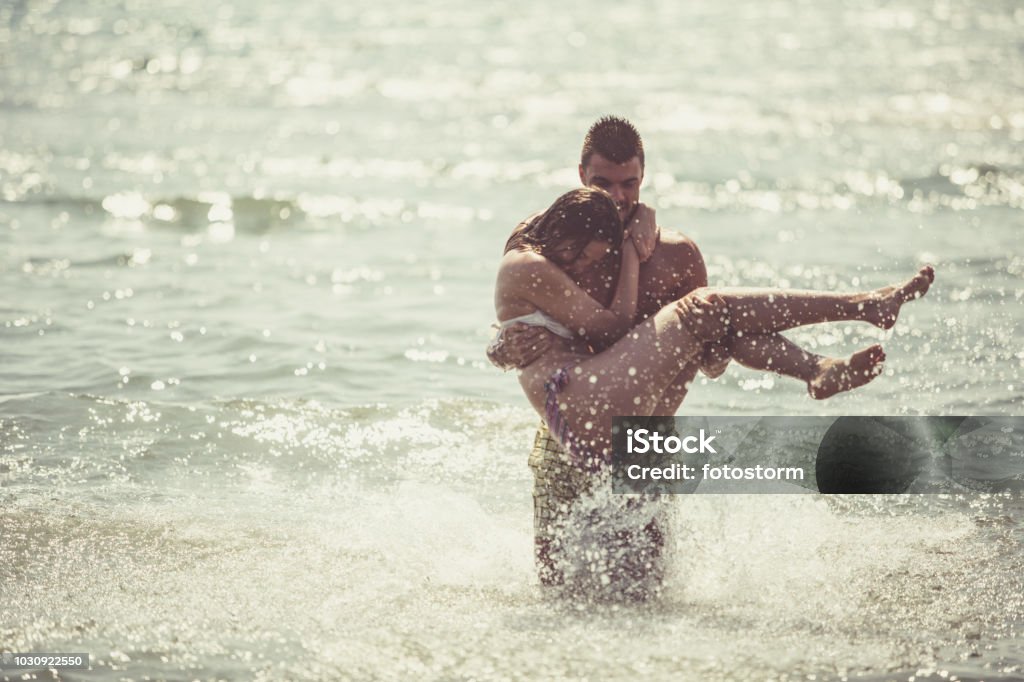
[495,187,934,470]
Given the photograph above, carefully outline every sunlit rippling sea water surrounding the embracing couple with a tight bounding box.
[0,0,1024,680]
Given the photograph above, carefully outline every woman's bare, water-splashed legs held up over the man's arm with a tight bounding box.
[558,267,934,453]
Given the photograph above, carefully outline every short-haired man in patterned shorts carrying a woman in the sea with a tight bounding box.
[487,116,728,598]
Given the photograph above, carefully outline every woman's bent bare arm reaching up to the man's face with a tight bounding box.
[496,239,640,345]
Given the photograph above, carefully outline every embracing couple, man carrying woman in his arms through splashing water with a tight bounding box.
[487,117,934,595]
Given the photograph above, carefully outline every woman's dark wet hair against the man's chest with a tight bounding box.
[505,187,623,265]
